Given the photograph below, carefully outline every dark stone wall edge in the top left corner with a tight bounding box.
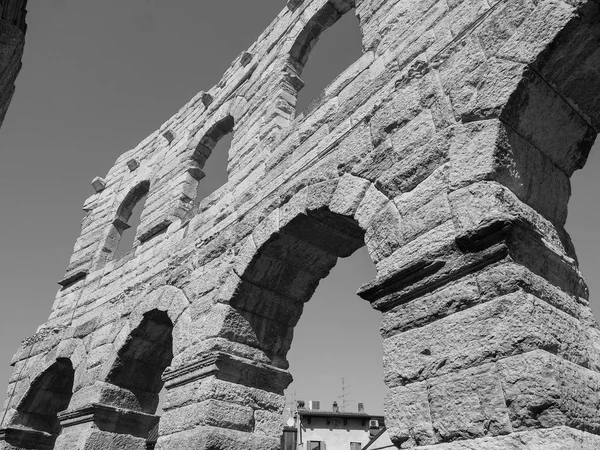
[0,0,27,126]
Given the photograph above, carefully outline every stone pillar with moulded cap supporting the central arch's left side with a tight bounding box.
[156,352,291,450]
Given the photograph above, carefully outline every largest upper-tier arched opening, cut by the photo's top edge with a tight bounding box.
[284,0,362,115]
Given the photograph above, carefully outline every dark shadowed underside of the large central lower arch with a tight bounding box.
[231,209,364,369]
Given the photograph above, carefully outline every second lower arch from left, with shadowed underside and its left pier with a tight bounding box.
[49,286,190,450]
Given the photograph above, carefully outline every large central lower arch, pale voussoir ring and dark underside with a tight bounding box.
[225,175,384,369]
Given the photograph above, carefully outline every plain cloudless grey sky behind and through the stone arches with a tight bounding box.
[0,0,600,422]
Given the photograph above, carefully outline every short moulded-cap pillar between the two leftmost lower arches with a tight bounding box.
[54,403,159,450]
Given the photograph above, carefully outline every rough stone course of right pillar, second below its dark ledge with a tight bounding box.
[383,292,598,386]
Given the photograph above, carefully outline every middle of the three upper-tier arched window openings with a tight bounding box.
[191,115,235,205]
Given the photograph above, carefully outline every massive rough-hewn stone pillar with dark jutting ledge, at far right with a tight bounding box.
[360,174,600,444]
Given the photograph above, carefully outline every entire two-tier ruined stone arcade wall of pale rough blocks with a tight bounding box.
[0,0,600,450]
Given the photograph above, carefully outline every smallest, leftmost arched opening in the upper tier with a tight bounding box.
[103,181,150,259]
